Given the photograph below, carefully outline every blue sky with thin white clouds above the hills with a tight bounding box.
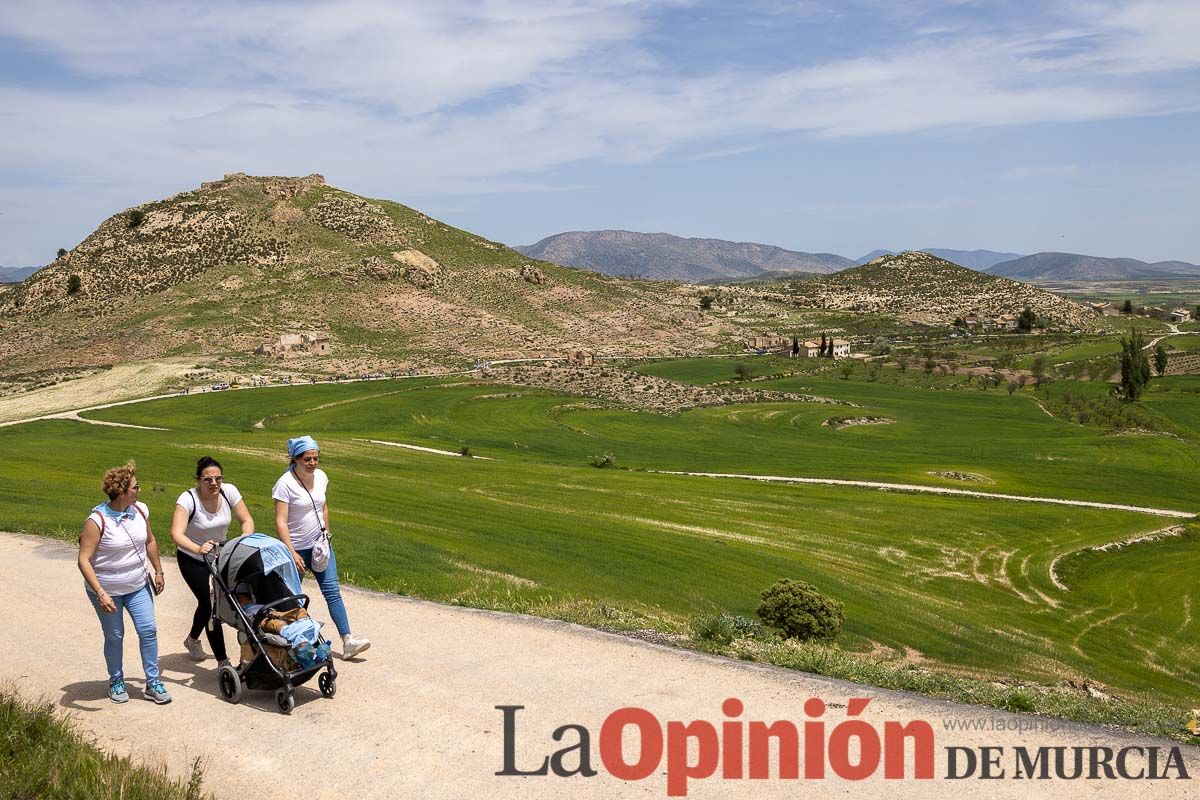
[0,0,1200,266]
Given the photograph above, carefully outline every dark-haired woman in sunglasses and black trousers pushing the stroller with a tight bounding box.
[170,456,254,666]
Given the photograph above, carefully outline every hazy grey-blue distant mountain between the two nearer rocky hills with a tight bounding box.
[516,230,853,283]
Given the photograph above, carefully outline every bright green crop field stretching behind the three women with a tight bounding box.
[0,367,1200,708]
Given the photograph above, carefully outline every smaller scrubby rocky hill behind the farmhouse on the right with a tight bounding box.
[781,252,1093,327]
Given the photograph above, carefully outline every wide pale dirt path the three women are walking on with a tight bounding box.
[0,534,1200,800]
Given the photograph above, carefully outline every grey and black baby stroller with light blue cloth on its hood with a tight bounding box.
[204,534,337,714]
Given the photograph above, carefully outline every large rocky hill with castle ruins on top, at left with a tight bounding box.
[0,173,737,374]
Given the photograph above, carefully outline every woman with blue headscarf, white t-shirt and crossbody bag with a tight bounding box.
[271,437,371,658]
